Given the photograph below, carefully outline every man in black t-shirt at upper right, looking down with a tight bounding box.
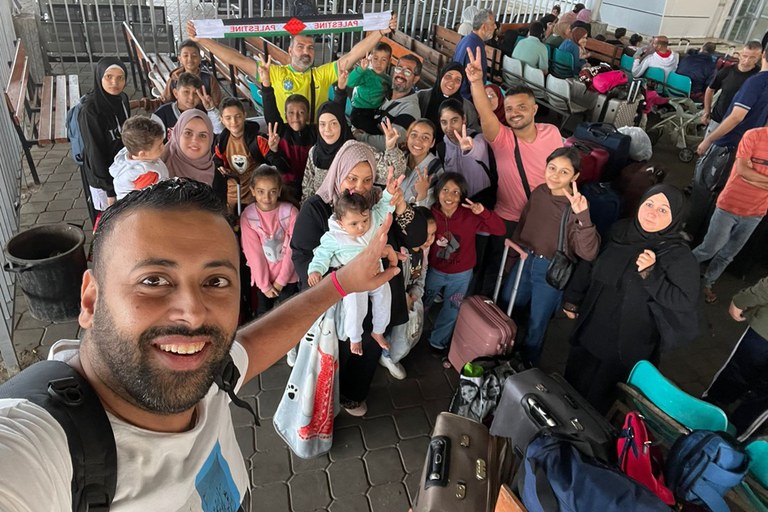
[701,41,763,135]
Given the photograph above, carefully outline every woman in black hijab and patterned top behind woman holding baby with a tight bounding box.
[301,101,354,200]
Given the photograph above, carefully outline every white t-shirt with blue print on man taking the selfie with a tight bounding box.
[0,340,249,512]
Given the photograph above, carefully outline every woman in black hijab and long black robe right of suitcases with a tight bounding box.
[563,184,699,413]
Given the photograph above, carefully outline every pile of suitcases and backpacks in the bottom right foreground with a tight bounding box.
[413,357,765,512]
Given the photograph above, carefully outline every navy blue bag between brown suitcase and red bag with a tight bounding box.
[515,433,670,512]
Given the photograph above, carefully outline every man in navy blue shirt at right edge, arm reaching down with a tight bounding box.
[685,50,768,242]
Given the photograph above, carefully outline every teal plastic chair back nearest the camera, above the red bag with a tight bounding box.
[627,361,728,432]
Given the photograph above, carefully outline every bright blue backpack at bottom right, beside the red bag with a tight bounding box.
[664,430,749,512]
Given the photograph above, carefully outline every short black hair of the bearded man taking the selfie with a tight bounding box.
[93,178,227,276]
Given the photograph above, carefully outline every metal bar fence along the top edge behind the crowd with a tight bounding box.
[38,0,575,72]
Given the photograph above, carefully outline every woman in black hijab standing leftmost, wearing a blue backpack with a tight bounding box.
[77,57,131,210]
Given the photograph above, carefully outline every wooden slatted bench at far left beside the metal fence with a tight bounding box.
[5,39,80,185]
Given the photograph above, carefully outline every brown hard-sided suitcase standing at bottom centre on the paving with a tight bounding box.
[413,412,513,512]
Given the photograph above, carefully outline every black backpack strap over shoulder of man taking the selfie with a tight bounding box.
[0,361,117,512]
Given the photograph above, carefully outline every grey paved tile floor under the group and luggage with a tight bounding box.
[4,126,764,512]
